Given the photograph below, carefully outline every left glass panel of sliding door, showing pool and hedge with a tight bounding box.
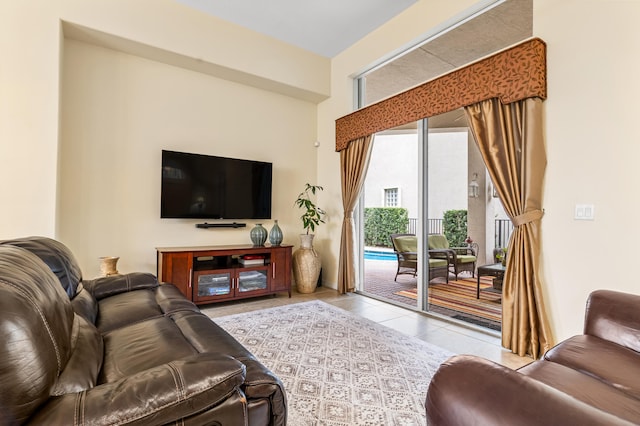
[358,124,421,309]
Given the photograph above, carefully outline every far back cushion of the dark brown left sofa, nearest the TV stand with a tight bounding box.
[0,237,82,299]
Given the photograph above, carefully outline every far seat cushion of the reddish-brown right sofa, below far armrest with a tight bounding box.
[544,335,640,400]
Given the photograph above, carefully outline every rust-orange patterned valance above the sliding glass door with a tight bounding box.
[336,38,547,151]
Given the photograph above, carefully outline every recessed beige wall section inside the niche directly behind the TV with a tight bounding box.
[56,40,316,276]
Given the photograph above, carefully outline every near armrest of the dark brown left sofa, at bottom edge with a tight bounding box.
[29,353,246,425]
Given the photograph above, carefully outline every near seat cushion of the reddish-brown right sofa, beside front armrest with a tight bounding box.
[518,361,640,424]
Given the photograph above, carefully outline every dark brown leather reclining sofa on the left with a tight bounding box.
[0,237,287,426]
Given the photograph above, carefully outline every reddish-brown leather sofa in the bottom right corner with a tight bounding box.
[426,290,640,426]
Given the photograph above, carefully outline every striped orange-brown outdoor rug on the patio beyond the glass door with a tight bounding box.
[396,277,502,330]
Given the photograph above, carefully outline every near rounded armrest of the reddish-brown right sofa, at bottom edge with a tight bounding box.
[426,355,631,426]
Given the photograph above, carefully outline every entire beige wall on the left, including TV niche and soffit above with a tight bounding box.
[0,0,330,276]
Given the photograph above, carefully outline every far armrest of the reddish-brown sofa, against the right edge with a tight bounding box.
[584,290,640,352]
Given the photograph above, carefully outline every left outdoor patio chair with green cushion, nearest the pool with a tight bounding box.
[390,234,449,282]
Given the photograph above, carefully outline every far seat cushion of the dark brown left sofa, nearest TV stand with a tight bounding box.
[96,284,198,333]
